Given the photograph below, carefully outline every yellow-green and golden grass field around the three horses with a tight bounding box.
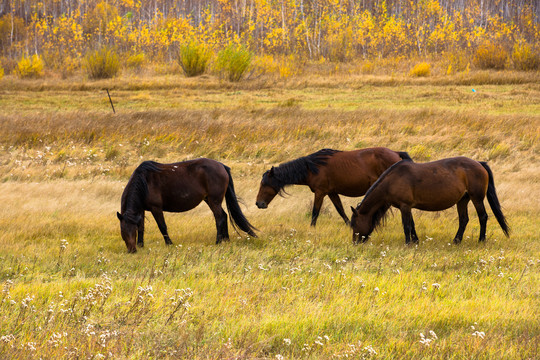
[0,73,540,359]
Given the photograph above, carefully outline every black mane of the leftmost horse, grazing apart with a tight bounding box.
[122,161,162,223]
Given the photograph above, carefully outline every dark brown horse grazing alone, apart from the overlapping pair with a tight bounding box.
[116,158,256,253]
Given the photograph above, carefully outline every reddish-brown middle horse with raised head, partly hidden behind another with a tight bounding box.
[256,147,410,226]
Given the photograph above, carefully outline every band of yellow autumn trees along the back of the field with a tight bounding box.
[0,0,540,73]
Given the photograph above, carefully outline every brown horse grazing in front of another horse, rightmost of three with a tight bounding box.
[351,157,509,244]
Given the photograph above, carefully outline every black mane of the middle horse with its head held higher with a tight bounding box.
[273,149,341,189]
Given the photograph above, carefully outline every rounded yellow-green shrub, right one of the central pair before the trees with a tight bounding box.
[216,44,253,81]
